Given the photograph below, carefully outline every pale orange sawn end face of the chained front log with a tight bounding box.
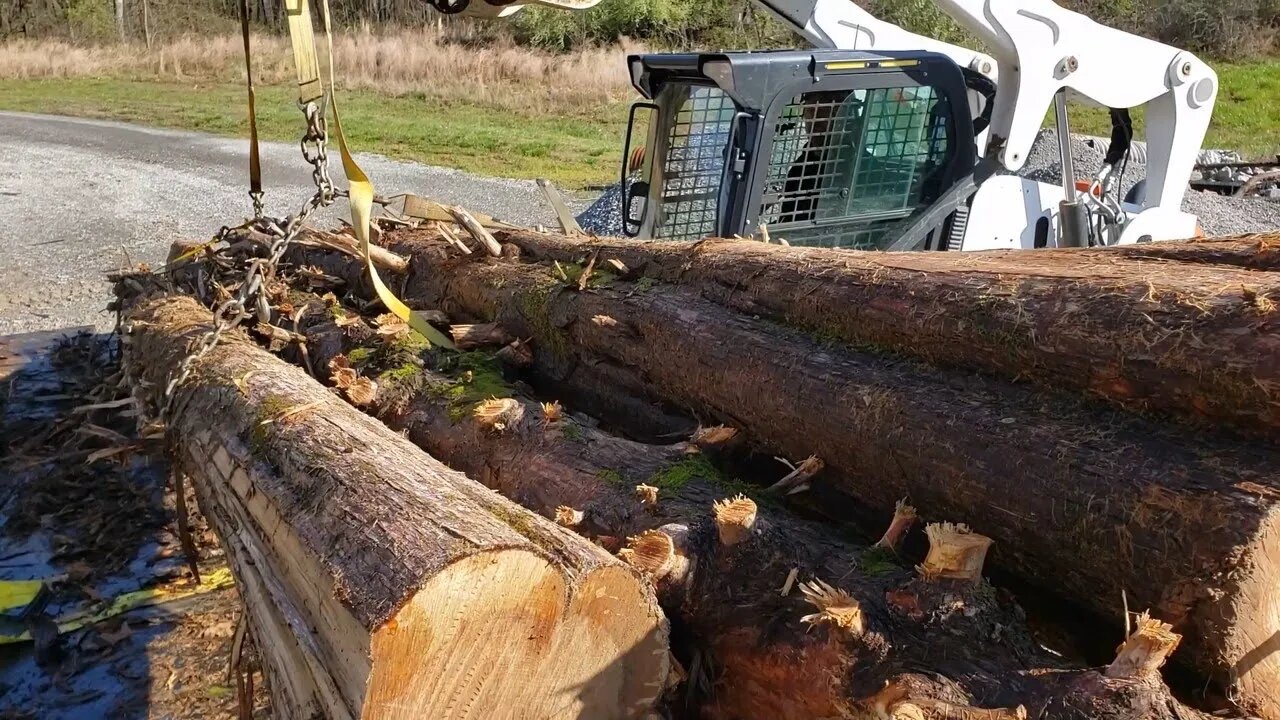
[362,551,667,720]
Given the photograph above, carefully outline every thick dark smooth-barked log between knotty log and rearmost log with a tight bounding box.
[350,233,1280,720]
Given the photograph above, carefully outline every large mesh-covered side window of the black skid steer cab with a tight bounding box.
[759,86,950,247]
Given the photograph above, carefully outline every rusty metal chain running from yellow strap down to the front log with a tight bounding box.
[149,100,338,423]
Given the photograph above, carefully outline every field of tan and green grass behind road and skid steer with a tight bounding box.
[0,31,1280,188]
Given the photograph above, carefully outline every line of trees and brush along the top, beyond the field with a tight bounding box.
[0,0,1280,59]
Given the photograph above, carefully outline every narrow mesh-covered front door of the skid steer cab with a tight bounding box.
[654,86,736,240]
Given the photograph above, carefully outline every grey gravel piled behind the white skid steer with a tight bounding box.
[577,129,1280,236]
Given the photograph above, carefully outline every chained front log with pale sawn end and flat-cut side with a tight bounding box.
[125,297,668,720]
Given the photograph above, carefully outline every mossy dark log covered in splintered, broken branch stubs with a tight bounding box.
[290,316,1202,720]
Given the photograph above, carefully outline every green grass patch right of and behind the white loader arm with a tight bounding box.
[1046,60,1280,159]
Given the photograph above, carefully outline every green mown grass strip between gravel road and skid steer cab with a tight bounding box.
[0,78,626,188]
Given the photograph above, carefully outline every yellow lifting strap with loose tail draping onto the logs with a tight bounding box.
[289,0,457,350]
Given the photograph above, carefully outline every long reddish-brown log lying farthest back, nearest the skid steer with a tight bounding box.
[500,232,1280,439]
